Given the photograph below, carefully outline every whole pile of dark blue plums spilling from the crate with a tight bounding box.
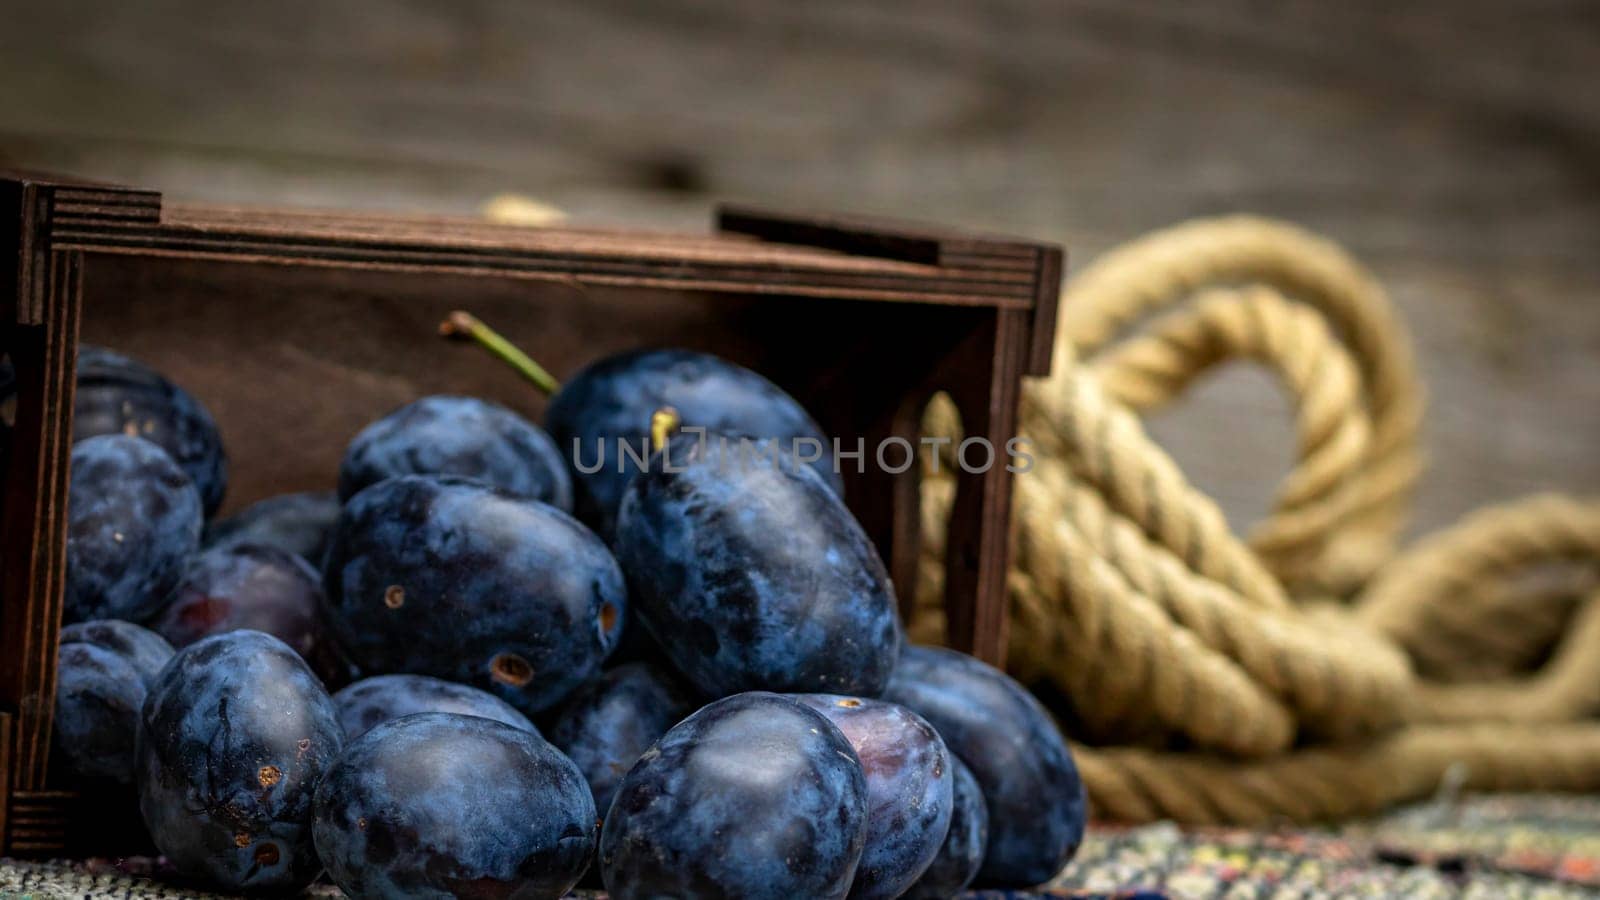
[54,337,1085,900]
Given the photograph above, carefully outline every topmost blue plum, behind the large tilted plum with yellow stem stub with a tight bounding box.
[544,349,843,540]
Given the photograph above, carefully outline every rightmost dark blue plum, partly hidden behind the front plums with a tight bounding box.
[883,647,1086,886]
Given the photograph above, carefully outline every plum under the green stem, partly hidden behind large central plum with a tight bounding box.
[339,396,573,509]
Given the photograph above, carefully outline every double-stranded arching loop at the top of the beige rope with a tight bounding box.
[1049,216,1424,596]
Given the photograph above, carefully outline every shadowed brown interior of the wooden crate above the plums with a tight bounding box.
[80,256,984,515]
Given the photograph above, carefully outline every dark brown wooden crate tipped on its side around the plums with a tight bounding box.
[0,175,1062,854]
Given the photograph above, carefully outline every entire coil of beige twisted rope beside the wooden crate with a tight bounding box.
[912,216,1600,825]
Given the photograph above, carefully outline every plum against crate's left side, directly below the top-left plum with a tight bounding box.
[62,434,202,623]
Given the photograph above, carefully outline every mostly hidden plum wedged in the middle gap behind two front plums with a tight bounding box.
[549,663,696,815]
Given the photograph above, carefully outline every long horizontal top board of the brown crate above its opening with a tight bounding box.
[50,207,1035,307]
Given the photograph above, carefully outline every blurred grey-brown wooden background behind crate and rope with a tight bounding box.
[0,0,1600,538]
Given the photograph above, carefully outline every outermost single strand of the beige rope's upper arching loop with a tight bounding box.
[1042,216,1422,591]
